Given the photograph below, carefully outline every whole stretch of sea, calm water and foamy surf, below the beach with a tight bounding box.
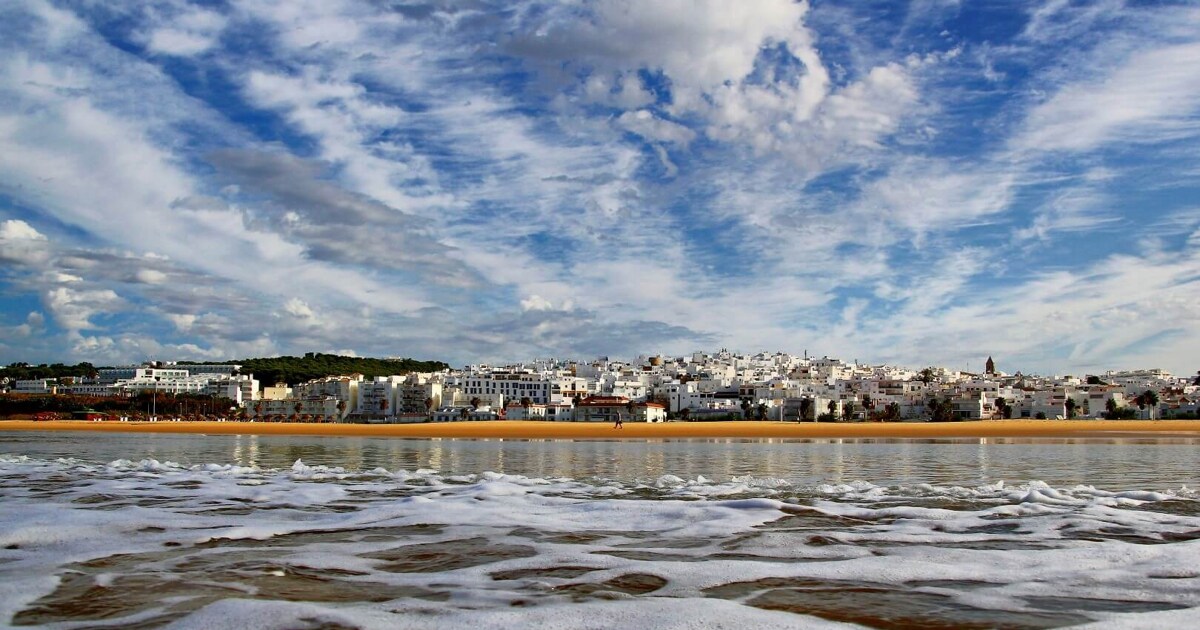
[0,432,1200,630]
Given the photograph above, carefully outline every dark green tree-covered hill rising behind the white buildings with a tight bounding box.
[179,353,450,386]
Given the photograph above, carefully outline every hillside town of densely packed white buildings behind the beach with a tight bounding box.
[2,350,1200,422]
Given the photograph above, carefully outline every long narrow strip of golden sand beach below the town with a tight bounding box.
[0,420,1200,439]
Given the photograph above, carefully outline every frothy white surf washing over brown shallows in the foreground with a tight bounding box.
[0,455,1200,628]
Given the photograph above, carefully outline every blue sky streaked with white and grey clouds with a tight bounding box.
[0,0,1200,374]
